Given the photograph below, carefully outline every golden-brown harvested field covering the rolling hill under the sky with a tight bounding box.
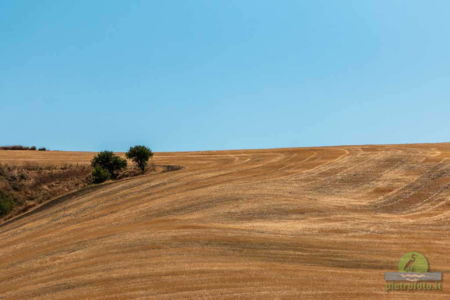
[0,144,450,299]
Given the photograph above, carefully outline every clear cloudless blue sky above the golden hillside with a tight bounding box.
[0,0,450,151]
